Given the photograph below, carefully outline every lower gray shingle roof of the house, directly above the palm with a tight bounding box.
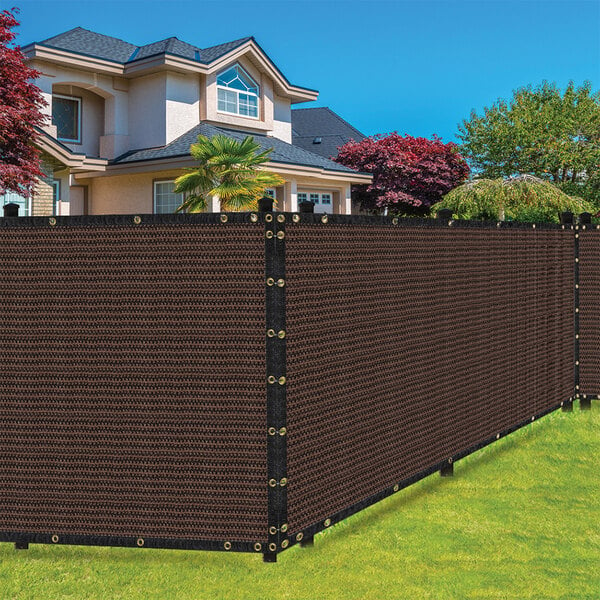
[112,123,356,173]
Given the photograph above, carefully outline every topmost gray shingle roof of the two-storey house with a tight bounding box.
[34,27,253,64]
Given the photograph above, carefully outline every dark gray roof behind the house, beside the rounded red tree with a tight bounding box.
[292,107,366,158]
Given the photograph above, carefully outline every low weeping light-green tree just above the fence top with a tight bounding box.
[432,175,594,223]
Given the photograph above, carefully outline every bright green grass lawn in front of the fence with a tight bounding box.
[0,402,600,600]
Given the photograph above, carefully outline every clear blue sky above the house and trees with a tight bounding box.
[10,0,600,141]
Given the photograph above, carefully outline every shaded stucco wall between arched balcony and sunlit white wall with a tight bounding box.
[129,73,167,150]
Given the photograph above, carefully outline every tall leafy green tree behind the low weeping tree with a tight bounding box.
[458,82,600,200]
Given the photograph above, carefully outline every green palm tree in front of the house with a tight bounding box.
[175,135,284,212]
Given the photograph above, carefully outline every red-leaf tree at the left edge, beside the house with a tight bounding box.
[0,8,46,197]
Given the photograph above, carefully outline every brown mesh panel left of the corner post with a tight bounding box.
[0,223,267,541]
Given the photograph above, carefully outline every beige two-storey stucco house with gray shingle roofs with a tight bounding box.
[4,27,370,215]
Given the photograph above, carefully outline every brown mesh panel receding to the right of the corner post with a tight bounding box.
[286,223,574,534]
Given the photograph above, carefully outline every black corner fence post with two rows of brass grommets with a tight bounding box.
[258,196,290,563]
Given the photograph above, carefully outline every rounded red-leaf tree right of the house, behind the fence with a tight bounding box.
[337,132,470,215]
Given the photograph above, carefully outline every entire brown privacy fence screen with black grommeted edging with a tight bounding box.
[0,213,600,560]
